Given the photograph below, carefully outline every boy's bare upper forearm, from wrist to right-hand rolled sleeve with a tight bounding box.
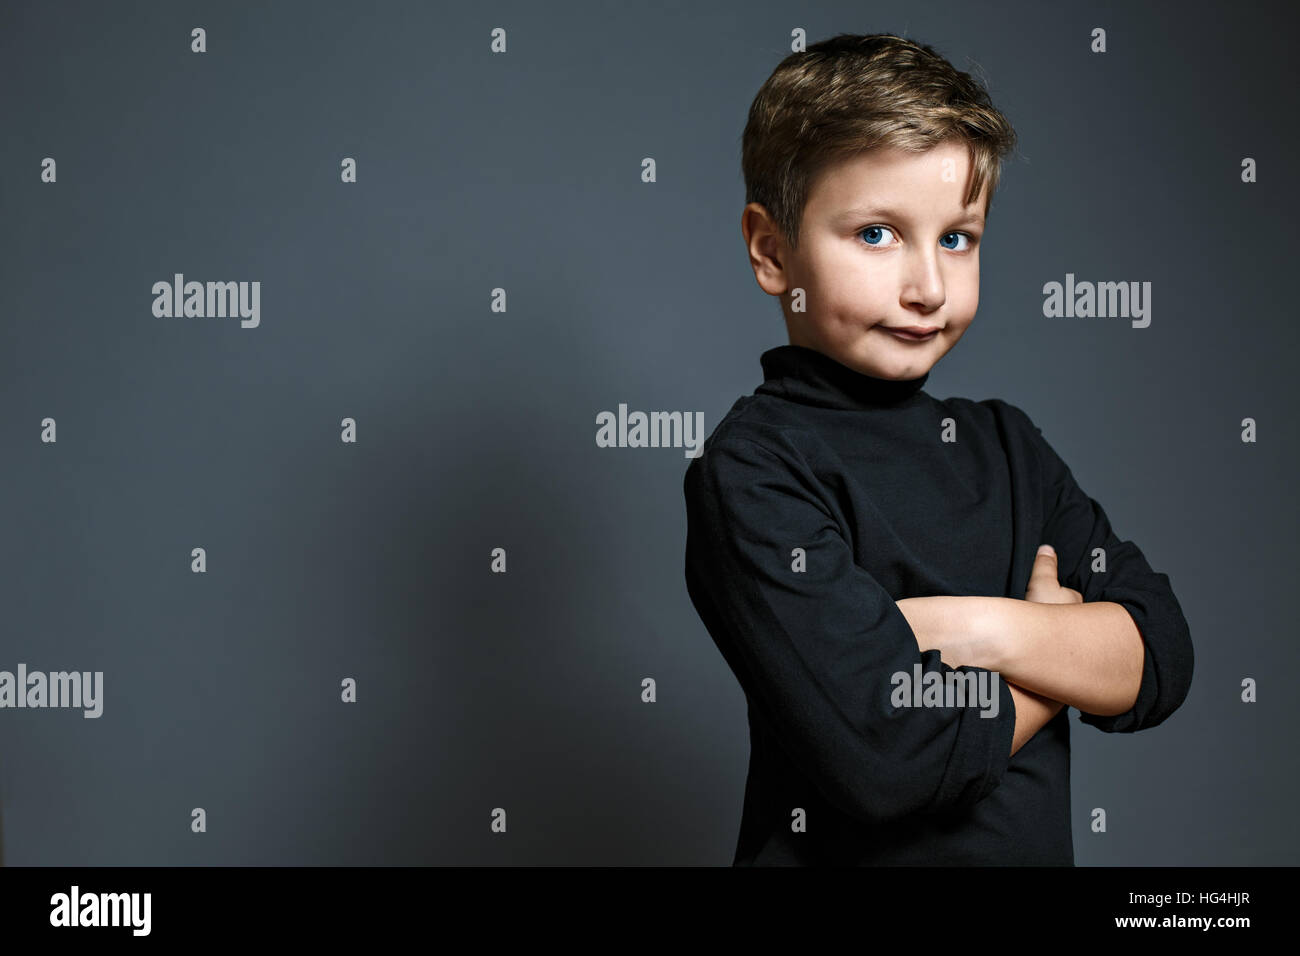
[982,597,1145,717]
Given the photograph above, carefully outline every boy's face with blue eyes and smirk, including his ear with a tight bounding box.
[741,143,988,378]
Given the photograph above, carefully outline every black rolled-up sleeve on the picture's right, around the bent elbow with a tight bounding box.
[1010,406,1193,734]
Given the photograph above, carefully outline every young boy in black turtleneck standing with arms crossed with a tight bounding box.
[684,35,1192,865]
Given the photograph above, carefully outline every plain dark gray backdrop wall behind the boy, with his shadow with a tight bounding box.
[0,3,1300,865]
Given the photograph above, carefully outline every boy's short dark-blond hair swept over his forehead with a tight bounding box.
[741,34,1015,248]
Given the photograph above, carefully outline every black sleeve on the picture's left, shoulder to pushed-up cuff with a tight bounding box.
[684,436,1015,823]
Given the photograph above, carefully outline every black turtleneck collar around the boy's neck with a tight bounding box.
[754,345,930,408]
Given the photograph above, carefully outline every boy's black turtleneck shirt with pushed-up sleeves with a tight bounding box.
[684,345,1192,866]
